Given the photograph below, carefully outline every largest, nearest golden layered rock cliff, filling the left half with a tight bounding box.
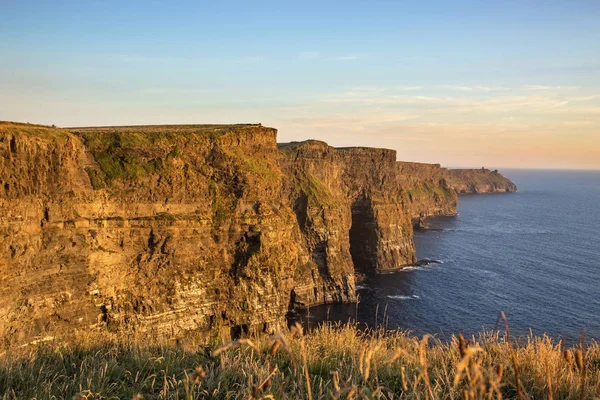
[0,124,309,340]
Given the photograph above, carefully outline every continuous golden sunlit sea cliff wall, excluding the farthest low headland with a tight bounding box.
[0,123,516,343]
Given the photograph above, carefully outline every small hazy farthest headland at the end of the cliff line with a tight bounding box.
[445,168,517,193]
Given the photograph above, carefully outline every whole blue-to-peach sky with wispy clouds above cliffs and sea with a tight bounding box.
[0,0,600,169]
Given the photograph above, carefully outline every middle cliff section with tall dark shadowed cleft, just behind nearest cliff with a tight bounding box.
[279,140,416,304]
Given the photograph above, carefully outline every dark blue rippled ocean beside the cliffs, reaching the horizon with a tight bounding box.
[306,170,600,342]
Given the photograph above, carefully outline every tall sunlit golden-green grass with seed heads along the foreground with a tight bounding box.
[0,324,600,399]
